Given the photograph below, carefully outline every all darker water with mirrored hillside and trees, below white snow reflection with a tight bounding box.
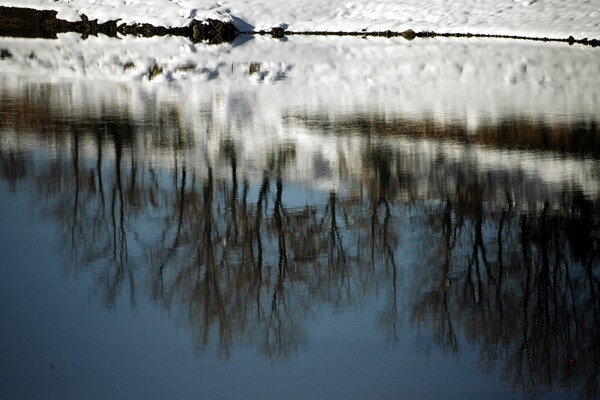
[0,76,600,399]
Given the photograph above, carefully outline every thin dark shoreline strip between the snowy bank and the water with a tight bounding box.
[0,6,600,47]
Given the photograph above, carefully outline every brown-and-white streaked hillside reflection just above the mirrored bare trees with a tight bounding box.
[0,83,600,204]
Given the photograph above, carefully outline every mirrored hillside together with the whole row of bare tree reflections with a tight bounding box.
[0,78,600,398]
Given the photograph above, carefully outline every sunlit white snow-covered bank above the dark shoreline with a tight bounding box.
[0,0,600,38]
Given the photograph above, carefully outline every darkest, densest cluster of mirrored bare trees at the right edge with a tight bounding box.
[414,159,600,398]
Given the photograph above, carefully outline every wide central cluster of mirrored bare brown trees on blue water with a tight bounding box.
[73,134,380,358]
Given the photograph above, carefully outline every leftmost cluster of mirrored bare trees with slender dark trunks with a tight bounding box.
[31,119,140,306]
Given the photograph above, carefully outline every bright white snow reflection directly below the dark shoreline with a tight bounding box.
[0,34,600,121]
